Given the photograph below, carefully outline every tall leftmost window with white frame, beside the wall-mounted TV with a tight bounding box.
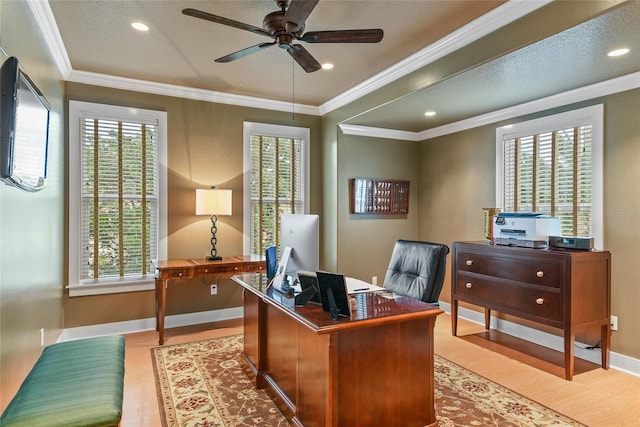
[69,101,166,296]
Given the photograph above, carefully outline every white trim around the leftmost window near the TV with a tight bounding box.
[67,100,167,297]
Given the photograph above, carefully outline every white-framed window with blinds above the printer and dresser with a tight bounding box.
[496,105,603,248]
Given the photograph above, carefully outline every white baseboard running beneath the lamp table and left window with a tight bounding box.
[58,307,244,341]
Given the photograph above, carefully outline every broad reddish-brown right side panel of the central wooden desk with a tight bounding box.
[334,316,435,426]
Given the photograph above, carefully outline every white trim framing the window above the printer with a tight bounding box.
[496,104,604,249]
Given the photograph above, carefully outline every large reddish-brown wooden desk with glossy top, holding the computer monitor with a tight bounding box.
[232,274,442,427]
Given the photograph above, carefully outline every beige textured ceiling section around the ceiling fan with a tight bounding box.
[49,0,503,106]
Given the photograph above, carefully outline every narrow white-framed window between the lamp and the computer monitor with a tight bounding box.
[243,122,309,255]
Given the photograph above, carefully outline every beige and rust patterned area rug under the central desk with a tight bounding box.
[151,335,583,427]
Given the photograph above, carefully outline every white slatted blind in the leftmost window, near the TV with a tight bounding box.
[80,117,159,280]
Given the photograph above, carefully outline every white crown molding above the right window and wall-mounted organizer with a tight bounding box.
[338,72,640,141]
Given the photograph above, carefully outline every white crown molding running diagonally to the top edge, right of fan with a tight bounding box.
[320,0,551,115]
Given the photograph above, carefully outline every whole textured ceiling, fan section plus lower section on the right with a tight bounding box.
[49,0,640,132]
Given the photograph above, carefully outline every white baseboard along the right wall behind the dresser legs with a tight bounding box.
[439,301,640,377]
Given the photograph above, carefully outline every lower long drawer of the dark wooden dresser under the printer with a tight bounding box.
[454,271,563,322]
